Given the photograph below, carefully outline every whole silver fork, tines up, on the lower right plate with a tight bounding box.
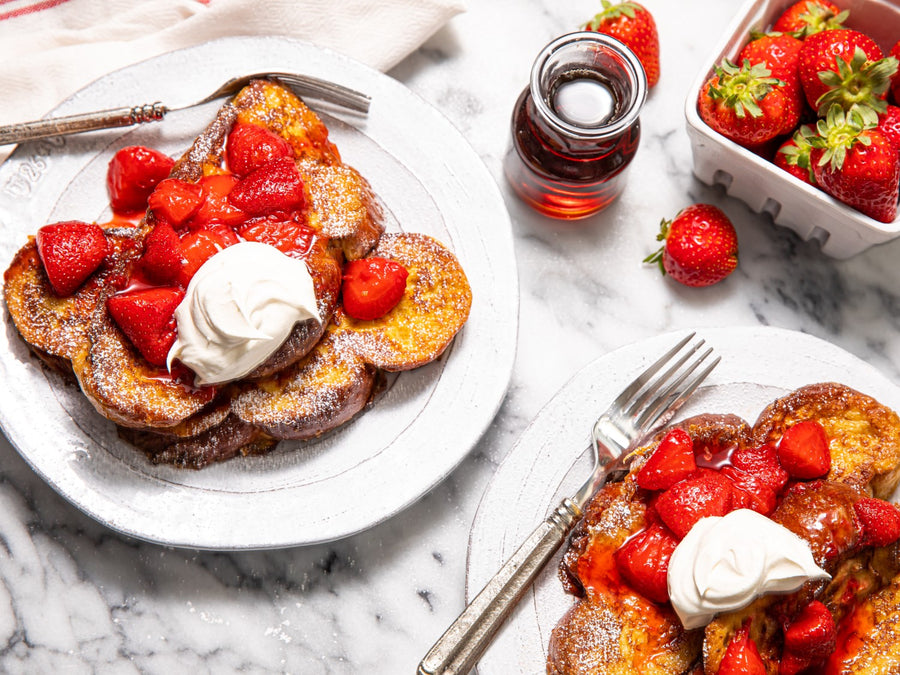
[418,333,720,675]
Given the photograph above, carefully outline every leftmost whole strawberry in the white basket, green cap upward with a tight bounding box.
[697,59,799,148]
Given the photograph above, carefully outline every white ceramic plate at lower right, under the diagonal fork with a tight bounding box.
[466,327,900,675]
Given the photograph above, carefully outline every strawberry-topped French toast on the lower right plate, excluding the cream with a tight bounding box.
[547,383,900,675]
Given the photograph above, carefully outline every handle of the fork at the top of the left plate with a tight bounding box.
[0,102,168,145]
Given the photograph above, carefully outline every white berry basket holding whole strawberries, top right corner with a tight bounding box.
[685,0,900,258]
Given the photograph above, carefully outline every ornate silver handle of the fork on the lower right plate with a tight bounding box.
[418,499,581,675]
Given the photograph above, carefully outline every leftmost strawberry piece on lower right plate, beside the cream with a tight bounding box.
[615,524,678,602]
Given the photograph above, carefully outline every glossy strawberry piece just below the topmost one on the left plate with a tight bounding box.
[228,157,306,216]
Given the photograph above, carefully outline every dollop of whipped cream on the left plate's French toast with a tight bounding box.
[167,241,322,384]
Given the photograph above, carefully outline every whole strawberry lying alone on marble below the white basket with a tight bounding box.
[644,204,738,286]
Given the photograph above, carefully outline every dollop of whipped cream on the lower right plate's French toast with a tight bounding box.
[668,509,831,630]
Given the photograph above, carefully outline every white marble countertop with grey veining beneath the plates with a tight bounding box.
[0,0,900,674]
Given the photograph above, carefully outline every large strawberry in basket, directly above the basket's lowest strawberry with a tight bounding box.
[800,30,897,121]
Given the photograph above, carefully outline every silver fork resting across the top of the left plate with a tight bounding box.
[0,73,371,145]
